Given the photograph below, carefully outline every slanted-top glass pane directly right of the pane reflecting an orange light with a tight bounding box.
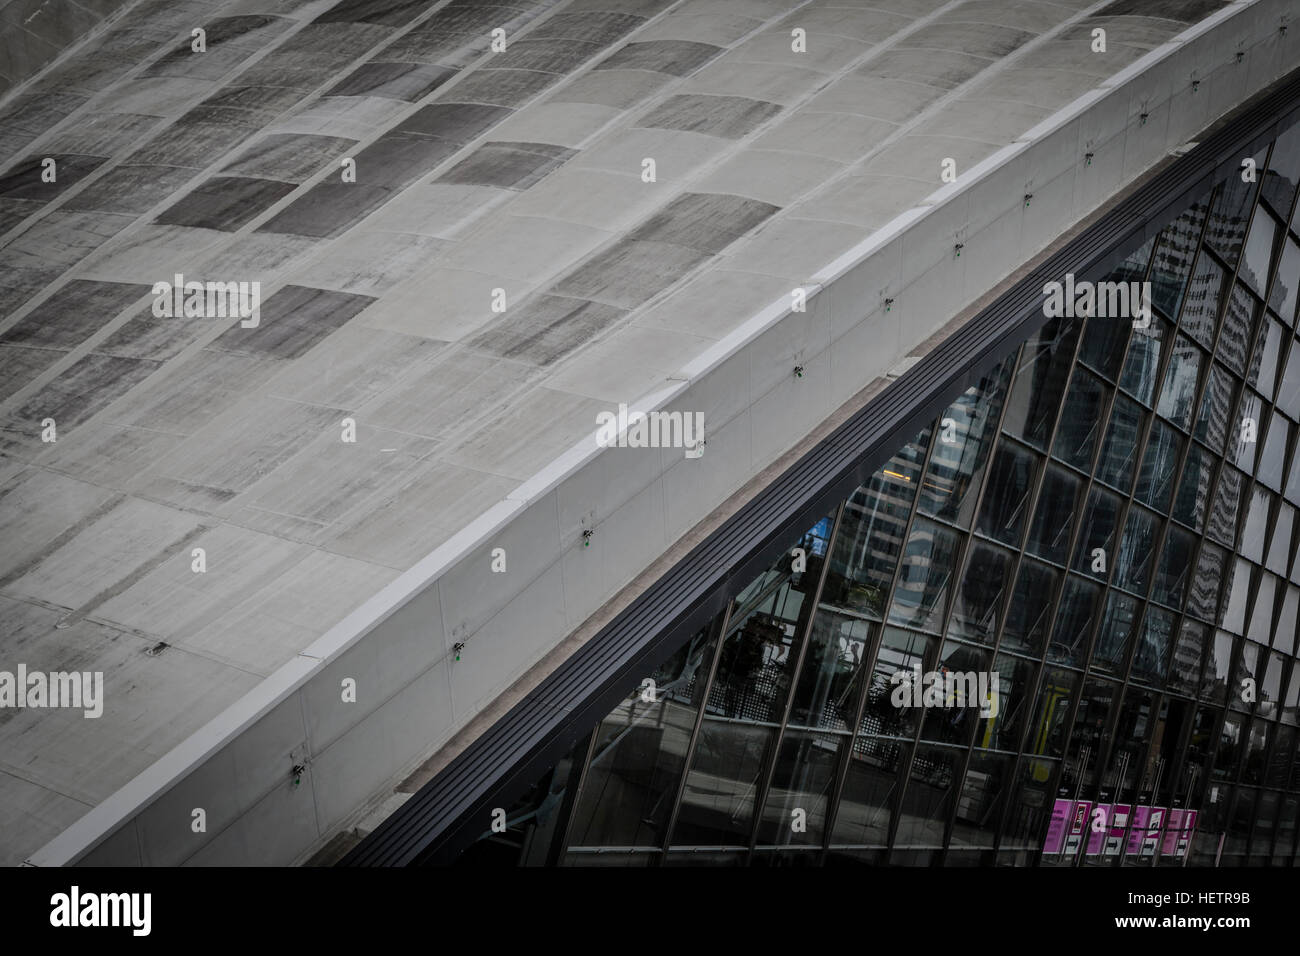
[919,364,1010,528]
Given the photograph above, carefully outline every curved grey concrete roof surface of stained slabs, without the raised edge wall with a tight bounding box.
[0,0,1258,862]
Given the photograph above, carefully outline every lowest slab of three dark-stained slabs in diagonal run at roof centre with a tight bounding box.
[467,295,627,367]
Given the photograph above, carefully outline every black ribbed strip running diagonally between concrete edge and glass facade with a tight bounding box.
[338,70,1300,866]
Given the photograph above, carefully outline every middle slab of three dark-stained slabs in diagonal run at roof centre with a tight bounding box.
[554,239,709,308]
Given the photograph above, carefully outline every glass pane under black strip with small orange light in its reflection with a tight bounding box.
[822,429,930,620]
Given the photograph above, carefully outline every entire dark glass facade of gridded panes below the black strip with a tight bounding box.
[449,117,1300,866]
